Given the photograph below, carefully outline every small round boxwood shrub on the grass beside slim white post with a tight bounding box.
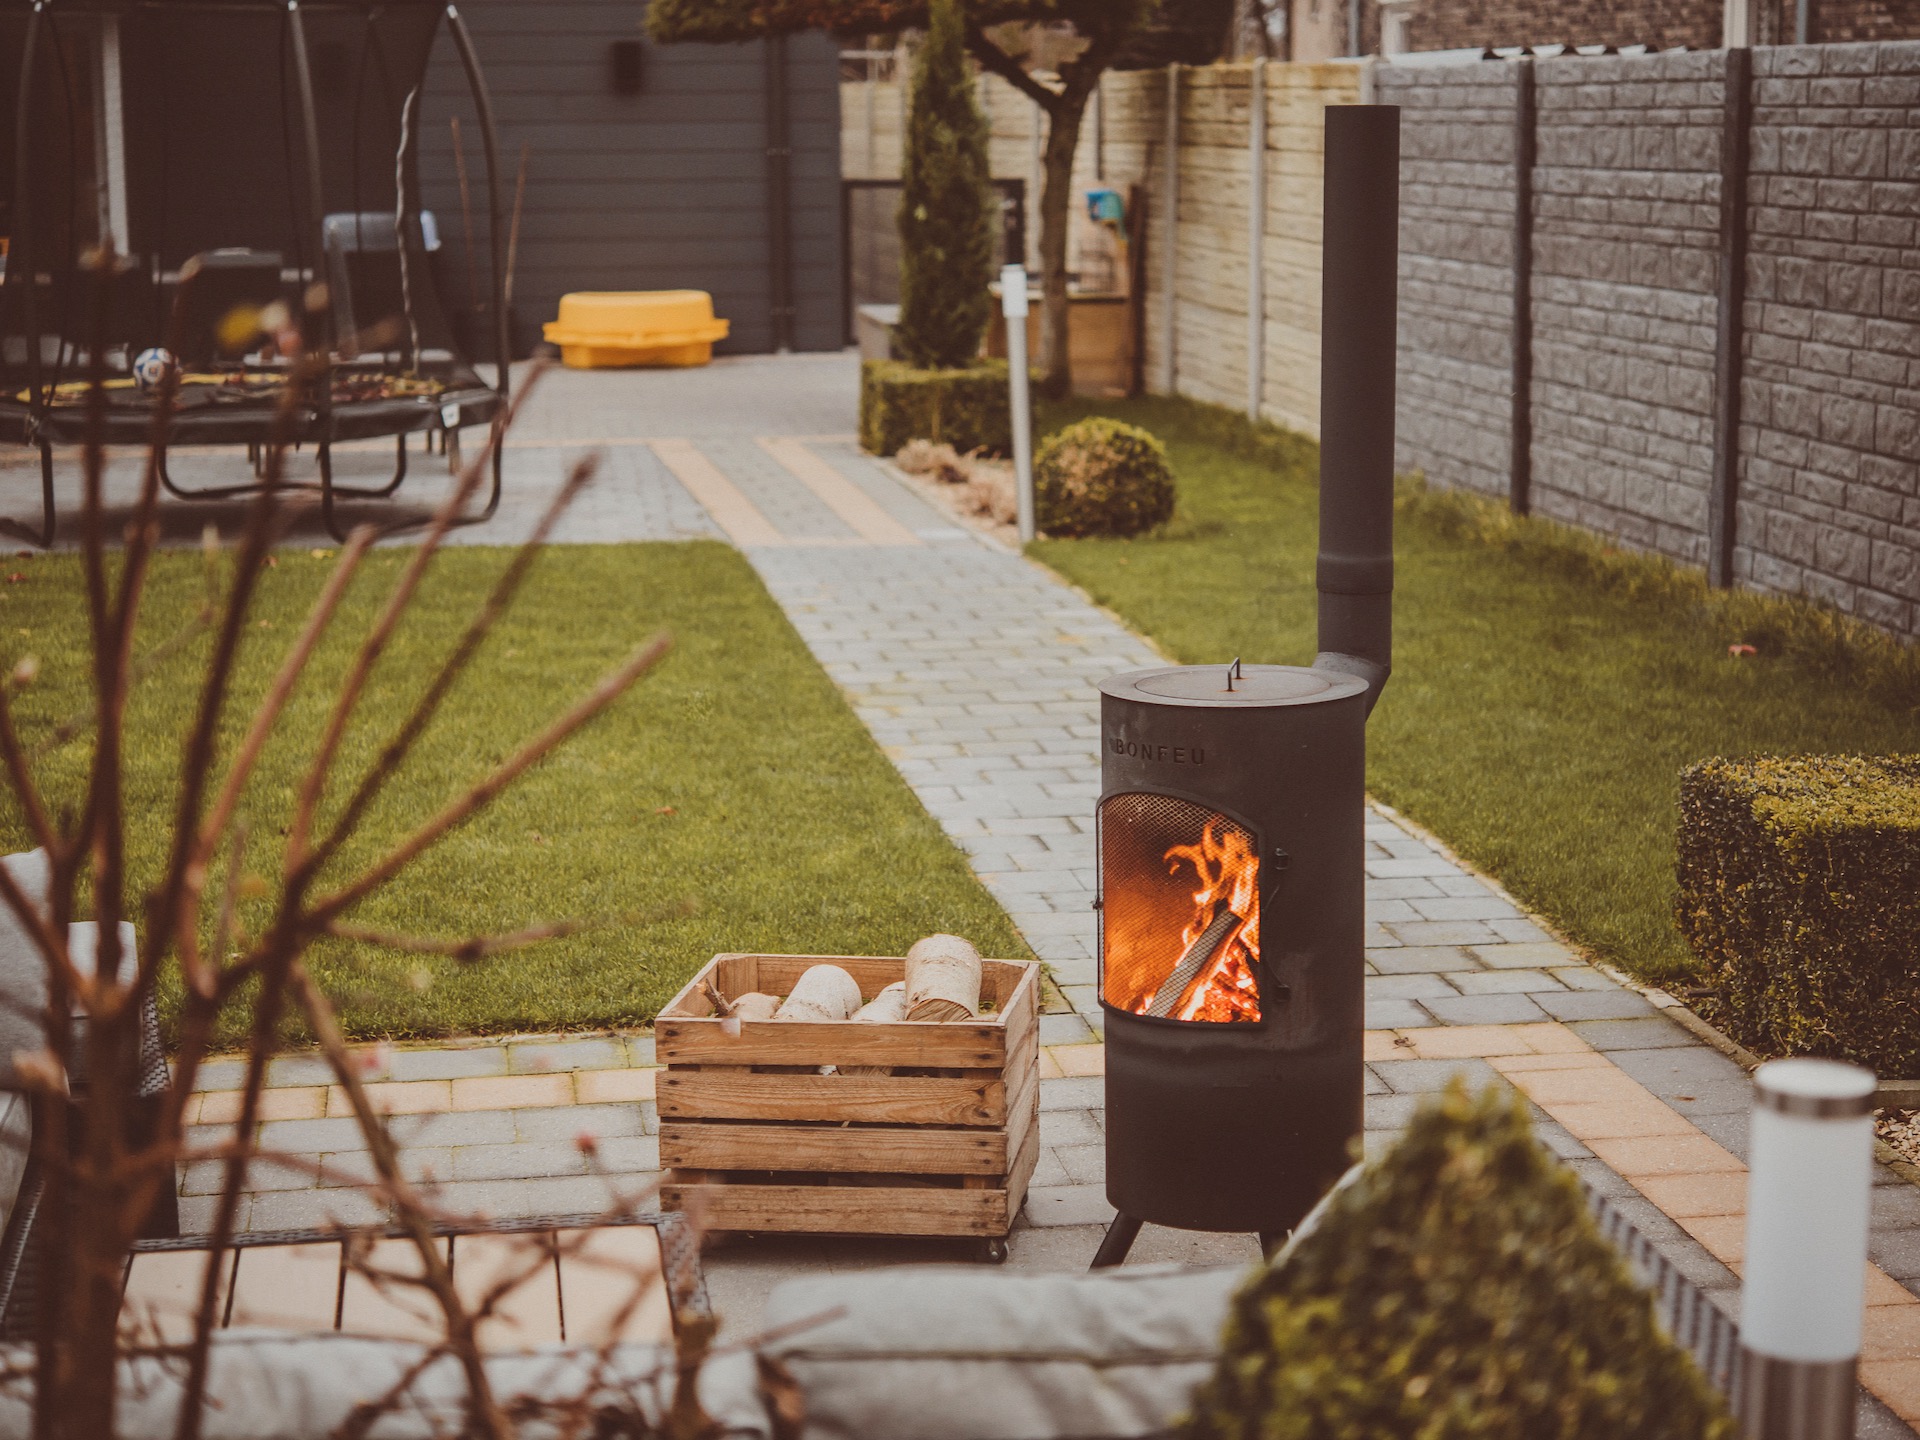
[1033,417,1173,538]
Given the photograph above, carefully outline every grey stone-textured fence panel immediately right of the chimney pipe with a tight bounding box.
[1379,65,1517,495]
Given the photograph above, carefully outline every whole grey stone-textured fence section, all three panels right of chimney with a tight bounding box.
[1379,42,1920,636]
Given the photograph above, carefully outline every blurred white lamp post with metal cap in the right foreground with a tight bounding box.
[1738,1060,1876,1440]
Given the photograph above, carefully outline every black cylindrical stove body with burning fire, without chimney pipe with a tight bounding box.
[1098,664,1367,1235]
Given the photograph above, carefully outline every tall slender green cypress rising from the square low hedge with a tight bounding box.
[895,0,993,371]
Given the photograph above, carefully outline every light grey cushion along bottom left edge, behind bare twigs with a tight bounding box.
[0,1331,770,1440]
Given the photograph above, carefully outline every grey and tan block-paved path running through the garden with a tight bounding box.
[161,362,1920,1436]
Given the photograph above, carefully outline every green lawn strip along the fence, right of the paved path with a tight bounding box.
[1033,399,1920,977]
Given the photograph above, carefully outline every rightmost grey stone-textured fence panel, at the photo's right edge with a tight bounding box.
[1734,42,1920,634]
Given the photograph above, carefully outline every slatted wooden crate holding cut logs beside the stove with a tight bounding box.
[653,954,1041,1240]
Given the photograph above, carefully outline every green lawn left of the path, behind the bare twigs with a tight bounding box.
[0,541,1025,1039]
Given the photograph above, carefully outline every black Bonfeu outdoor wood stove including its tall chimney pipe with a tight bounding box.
[1094,106,1400,1267]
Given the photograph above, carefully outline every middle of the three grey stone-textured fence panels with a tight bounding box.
[1532,52,1726,563]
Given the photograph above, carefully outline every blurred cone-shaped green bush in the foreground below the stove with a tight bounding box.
[1179,1081,1734,1440]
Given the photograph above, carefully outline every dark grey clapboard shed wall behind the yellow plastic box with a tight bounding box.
[420,0,843,357]
